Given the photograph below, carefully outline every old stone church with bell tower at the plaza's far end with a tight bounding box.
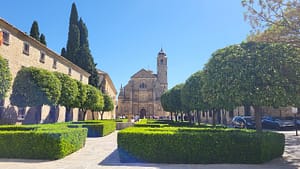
[117,49,168,118]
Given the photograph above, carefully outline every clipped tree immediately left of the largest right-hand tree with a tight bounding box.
[181,71,207,125]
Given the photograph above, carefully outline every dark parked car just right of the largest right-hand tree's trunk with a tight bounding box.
[262,116,295,130]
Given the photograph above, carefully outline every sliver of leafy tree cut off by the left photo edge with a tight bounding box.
[0,56,12,119]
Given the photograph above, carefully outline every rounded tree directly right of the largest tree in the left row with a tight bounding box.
[54,72,79,122]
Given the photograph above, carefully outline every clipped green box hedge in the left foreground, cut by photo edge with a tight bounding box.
[0,125,87,160]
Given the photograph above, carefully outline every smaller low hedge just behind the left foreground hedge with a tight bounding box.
[68,120,116,137]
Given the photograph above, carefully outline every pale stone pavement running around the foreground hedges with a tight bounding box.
[0,131,300,169]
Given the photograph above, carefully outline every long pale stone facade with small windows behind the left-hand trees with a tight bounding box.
[0,18,90,122]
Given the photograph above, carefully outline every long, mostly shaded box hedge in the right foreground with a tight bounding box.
[118,127,284,164]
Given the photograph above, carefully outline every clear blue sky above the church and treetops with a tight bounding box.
[0,0,251,91]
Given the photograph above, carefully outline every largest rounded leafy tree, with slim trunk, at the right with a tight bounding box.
[203,42,300,131]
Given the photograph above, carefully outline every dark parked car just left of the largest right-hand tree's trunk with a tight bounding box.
[231,116,255,129]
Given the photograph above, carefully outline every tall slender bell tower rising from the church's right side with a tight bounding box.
[157,48,168,91]
